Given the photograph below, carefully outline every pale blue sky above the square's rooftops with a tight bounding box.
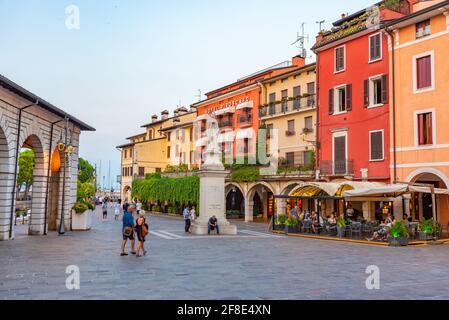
[0,0,375,188]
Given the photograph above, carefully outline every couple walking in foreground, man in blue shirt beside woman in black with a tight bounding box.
[121,211,149,258]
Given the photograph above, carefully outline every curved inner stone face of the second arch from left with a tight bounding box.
[20,134,47,235]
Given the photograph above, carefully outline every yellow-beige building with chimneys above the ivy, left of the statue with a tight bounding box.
[117,107,196,200]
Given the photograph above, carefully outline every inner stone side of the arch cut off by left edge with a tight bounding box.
[0,116,14,240]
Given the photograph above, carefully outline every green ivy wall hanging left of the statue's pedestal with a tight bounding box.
[132,176,200,204]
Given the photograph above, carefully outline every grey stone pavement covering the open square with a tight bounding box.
[0,208,449,300]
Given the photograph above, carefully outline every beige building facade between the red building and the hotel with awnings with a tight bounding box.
[259,63,317,170]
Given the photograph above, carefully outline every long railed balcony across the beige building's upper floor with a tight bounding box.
[259,95,316,118]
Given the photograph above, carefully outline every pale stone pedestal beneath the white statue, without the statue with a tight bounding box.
[191,170,237,235]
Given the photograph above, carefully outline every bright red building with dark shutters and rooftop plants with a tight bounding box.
[313,1,409,183]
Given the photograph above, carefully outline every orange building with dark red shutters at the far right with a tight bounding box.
[388,0,449,224]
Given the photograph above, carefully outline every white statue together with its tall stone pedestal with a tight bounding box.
[191,117,237,235]
